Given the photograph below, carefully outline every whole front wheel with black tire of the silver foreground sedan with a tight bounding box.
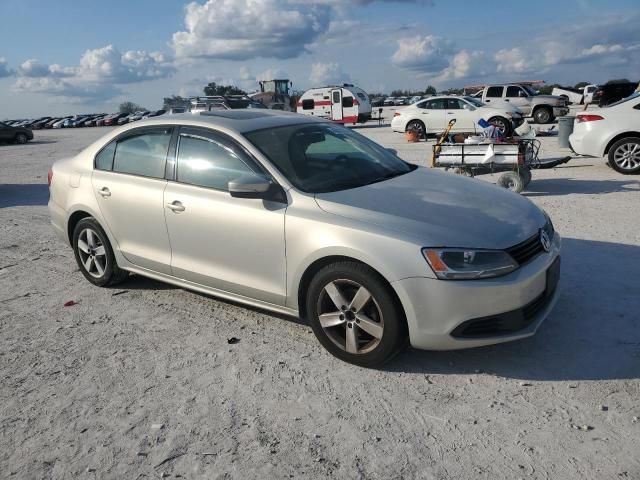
[306,262,407,368]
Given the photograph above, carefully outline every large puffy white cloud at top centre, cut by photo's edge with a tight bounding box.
[171,0,332,60]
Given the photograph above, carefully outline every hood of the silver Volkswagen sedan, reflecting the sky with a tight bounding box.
[316,168,546,249]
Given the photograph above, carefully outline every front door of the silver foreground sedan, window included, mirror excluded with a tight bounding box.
[164,127,286,305]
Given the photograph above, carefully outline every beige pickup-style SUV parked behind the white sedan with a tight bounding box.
[478,84,569,123]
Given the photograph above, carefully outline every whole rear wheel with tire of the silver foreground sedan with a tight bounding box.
[73,217,129,287]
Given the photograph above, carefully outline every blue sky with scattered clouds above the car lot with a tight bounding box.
[0,0,640,119]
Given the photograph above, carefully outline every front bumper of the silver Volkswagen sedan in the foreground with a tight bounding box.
[392,232,561,350]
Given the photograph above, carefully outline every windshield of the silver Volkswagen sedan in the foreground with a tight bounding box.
[245,124,417,193]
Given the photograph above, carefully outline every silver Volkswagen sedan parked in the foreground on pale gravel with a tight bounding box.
[49,110,560,367]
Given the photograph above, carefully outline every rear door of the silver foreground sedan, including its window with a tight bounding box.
[91,127,172,274]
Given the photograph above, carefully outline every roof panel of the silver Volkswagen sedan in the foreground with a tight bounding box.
[128,109,326,133]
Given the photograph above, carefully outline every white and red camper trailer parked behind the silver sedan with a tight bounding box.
[297,83,371,125]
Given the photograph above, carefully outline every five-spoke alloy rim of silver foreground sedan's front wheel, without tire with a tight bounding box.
[317,279,384,355]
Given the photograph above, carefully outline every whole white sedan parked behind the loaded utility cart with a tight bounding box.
[391,96,523,136]
